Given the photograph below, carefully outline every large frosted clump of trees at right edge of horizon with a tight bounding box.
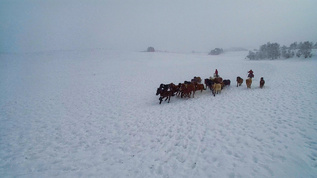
[247,41,317,60]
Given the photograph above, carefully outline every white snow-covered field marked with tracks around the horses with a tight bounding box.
[0,50,317,178]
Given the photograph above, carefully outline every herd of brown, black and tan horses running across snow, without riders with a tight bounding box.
[156,76,265,104]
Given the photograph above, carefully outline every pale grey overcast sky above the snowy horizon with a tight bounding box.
[0,0,317,52]
